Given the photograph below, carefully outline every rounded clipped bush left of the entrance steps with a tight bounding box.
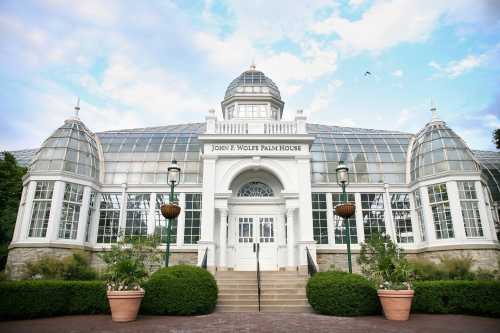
[141,265,218,315]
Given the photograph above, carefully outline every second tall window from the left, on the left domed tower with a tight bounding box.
[58,183,83,239]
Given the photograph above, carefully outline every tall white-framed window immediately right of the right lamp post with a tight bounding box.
[361,193,385,239]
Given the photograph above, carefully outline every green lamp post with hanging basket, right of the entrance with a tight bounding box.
[335,161,355,273]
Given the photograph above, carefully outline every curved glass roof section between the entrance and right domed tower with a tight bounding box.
[307,124,411,184]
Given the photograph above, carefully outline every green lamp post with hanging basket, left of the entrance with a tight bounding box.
[160,160,181,267]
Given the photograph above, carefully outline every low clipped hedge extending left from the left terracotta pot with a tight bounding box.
[0,280,109,320]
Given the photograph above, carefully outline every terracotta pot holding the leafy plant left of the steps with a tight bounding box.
[108,290,144,322]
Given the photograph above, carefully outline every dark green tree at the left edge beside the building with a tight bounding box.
[0,152,27,271]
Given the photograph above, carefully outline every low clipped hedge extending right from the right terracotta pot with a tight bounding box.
[412,281,500,317]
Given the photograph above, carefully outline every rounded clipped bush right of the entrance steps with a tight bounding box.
[306,272,380,316]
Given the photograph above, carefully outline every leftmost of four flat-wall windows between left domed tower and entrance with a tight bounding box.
[97,193,122,243]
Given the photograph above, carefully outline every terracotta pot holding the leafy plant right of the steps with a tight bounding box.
[377,289,415,320]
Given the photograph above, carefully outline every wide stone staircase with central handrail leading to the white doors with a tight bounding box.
[215,271,312,313]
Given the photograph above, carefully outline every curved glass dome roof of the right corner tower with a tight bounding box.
[411,120,480,181]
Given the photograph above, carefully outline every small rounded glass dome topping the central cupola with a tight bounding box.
[224,66,281,100]
